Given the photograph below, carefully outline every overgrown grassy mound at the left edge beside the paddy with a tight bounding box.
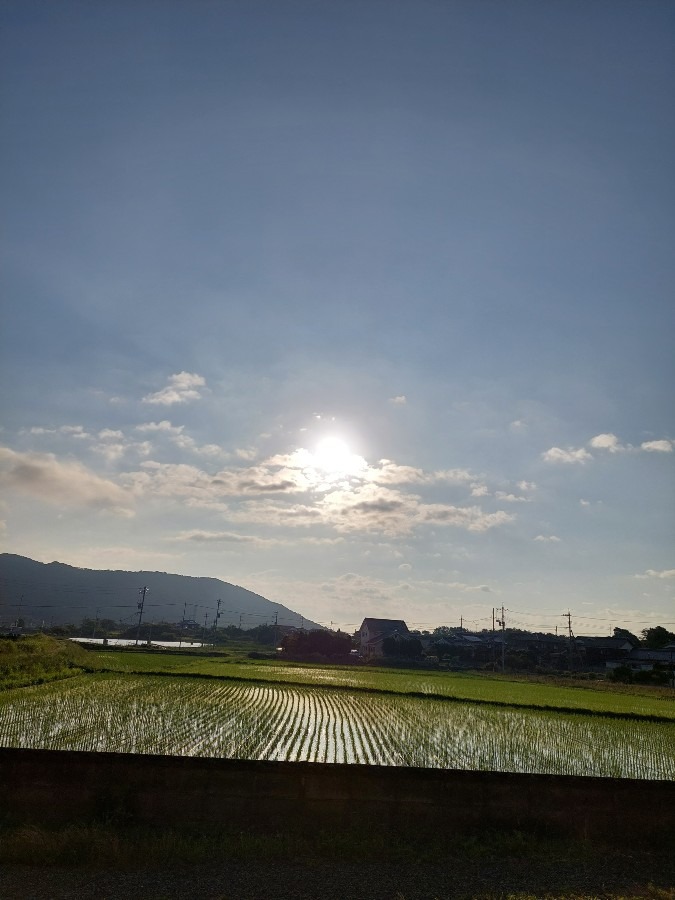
[0,634,92,690]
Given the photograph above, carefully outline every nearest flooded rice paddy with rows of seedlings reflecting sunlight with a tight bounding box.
[0,675,675,780]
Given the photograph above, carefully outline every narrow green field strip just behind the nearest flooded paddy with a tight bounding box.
[89,651,675,721]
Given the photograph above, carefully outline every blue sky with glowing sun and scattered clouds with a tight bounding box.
[0,0,675,634]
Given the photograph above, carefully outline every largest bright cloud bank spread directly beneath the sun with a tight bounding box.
[113,442,526,536]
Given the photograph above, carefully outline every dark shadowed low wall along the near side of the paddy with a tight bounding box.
[0,748,675,847]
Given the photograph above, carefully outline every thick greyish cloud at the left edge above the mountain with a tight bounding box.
[0,447,133,515]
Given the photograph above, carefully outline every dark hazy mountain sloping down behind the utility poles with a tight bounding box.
[0,553,320,628]
